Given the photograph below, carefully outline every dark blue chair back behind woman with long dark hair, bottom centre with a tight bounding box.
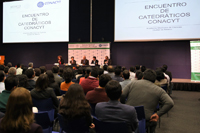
[58,114,89,133]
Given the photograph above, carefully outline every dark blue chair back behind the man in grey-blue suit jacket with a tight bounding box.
[93,117,129,133]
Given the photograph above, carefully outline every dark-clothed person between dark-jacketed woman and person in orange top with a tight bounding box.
[46,70,60,96]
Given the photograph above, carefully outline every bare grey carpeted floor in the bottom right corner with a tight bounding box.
[156,91,200,133]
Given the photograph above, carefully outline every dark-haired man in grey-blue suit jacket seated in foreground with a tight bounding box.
[95,80,138,132]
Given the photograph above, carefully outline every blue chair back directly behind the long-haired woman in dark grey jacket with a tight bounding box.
[32,98,54,111]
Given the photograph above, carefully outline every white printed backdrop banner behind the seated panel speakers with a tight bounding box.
[68,42,110,65]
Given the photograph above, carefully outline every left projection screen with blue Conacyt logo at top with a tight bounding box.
[3,0,69,43]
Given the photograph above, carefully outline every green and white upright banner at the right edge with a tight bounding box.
[190,41,200,81]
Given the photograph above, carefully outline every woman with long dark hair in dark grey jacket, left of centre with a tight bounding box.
[31,74,59,114]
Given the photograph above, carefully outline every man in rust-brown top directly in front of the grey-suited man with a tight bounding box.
[86,74,112,104]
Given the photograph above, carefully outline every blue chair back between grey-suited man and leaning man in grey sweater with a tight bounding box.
[135,106,146,133]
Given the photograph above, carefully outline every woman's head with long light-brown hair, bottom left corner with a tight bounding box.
[1,87,34,133]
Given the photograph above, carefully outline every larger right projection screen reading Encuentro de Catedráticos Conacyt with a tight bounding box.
[114,0,200,42]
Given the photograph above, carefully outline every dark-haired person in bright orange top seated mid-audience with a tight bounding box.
[60,68,74,91]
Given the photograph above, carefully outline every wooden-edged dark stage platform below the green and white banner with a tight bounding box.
[171,78,200,91]
